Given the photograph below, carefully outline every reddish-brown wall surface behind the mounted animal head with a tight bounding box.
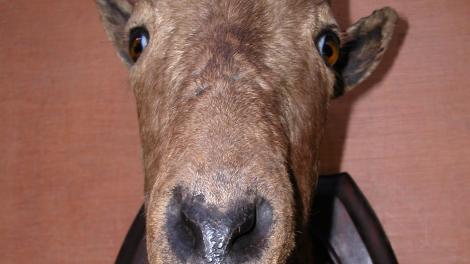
[0,0,470,264]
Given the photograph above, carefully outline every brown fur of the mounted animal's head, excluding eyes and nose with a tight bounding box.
[97,0,396,263]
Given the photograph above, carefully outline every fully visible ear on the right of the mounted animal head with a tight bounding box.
[335,7,398,96]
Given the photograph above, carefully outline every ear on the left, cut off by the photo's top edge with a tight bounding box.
[96,0,135,65]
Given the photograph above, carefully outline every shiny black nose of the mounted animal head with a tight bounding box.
[166,188,272,263]
